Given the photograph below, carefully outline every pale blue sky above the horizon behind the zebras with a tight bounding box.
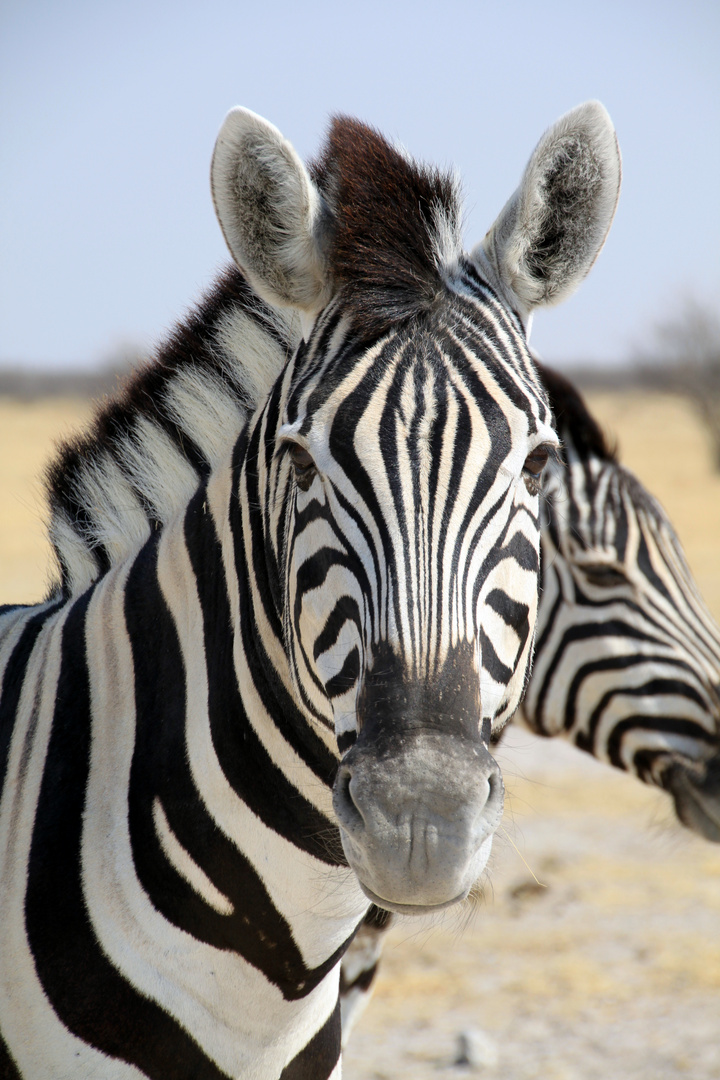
[0,0,720,367]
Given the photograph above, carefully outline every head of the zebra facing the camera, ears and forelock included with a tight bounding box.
[213,103,620,913]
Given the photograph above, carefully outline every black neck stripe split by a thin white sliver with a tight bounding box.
[125,550,354,1000]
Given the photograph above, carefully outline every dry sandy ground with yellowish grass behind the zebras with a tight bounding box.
[0,393,720,1080]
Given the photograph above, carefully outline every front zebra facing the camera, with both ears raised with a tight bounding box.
[0,103,621,1080]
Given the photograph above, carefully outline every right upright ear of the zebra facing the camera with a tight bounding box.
[473,102,621,314]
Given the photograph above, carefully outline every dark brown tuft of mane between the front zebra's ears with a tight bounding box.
[309,117,462,334]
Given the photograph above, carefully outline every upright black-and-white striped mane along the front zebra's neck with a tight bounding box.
[45,267,299,595]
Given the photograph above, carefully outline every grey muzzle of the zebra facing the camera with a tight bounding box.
[334,730,504,915]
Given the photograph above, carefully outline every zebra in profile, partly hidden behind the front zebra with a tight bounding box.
[341,365,720,1041]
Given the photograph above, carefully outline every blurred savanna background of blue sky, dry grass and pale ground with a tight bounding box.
[0,0,720,1080]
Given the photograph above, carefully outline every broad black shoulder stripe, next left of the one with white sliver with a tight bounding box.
[25,591,225,1080]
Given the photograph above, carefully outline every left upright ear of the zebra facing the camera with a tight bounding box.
[210,108,329,311]
